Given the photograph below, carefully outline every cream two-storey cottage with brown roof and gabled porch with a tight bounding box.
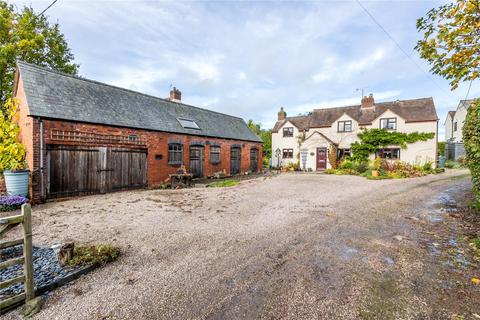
[272,94,438,171]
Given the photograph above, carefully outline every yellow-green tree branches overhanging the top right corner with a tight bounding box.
[415,0,480,89]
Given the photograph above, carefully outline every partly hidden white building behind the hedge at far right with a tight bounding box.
[444,99,475,160]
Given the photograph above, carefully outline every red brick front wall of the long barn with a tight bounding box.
[27,119,262,202]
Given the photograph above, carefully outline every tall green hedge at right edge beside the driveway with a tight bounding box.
[463,99,480,209]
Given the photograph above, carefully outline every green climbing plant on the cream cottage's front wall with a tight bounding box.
[351,129,435,161]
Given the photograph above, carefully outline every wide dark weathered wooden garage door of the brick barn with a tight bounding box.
[47,145,147,198]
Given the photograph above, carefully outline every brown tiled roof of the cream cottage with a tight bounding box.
[272,98,438,132]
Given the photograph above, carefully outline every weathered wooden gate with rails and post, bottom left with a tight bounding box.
[0,204,35,314]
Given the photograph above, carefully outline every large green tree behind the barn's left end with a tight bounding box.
[0,0,78,109]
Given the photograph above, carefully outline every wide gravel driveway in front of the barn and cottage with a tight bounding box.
[4,170,478,319]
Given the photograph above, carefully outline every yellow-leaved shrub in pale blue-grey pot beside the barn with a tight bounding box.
[0,99,30,197]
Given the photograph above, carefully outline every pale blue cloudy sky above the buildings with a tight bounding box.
[8,0,480,137]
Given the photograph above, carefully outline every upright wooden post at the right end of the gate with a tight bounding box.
[22,204,35,301]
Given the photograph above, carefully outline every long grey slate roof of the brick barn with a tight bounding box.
[17,61,262,142]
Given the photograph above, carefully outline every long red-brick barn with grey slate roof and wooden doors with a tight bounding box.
[14,62,262,202]
